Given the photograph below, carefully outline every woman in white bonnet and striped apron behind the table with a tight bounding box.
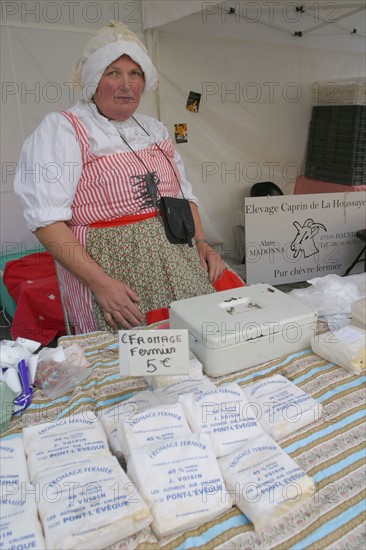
[15,22,234,333]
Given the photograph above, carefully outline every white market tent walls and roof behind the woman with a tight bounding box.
[1,0,366,256]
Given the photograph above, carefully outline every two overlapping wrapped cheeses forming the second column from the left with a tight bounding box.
[23,411,152,549]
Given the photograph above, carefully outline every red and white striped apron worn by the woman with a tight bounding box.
[59,111,179,333]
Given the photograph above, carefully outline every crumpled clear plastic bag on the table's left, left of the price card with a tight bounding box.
[35,361,88,399]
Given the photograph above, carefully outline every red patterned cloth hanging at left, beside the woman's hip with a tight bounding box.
[3,252,66,346]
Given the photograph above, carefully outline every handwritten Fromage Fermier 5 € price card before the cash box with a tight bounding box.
[118,329,189,376]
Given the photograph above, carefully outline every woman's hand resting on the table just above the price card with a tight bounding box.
[91,275,144,330]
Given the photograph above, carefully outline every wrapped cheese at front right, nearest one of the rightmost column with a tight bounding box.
[218,433,315,530]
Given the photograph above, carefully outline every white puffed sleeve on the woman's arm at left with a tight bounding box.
[14,113,82,231]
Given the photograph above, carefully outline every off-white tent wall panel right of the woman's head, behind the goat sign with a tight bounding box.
[157,32,364,251]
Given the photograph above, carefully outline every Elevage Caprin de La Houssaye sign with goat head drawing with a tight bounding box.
[245,192,366,285]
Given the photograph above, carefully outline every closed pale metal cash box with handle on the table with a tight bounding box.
[169,283,317,377]
